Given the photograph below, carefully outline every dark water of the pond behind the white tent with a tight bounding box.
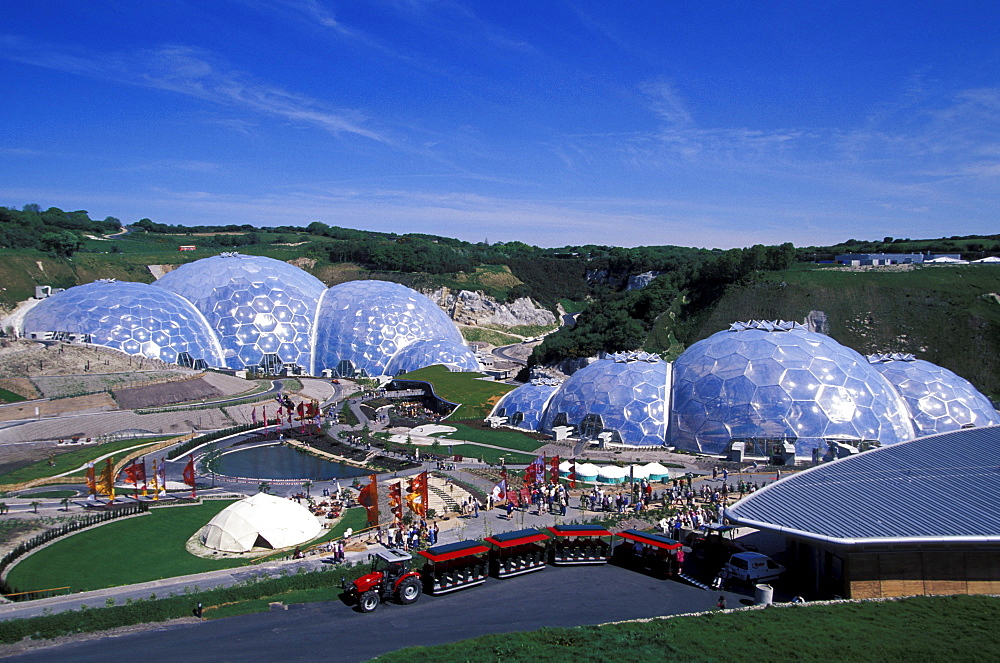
[216,444,370,481]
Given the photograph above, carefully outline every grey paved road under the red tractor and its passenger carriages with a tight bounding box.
[5,566,744,663]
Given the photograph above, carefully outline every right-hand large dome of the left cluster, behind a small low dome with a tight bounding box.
[312,281,468,375]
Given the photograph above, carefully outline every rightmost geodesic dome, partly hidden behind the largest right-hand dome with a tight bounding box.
[868,353,1000,437]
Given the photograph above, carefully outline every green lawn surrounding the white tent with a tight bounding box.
[7,500,365,592]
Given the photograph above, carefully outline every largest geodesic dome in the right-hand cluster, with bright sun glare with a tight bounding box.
[670,321,913,456]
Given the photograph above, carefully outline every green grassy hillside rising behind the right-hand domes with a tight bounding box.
[675,265,1000,399]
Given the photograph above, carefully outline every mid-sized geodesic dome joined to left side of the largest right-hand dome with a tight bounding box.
[541,352,670,446]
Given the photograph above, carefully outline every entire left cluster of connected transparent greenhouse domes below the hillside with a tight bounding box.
[21,253,480,377]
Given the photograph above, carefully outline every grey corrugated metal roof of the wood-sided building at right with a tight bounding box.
[726,426,1000,543]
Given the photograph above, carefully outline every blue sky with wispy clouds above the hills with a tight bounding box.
[0,0,1000,248]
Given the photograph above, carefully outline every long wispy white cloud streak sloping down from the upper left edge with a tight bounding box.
[0,35,391,143]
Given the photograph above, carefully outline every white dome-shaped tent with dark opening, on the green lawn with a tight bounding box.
[201,493,323,552]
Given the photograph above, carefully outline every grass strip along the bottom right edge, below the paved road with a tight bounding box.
[376,596,1000,663]
